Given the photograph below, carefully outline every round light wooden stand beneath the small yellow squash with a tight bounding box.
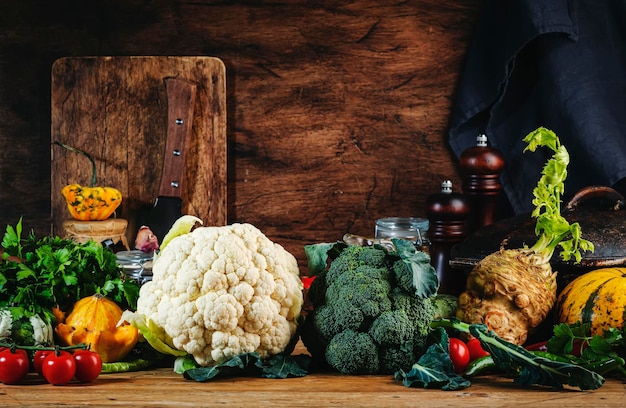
[63,218,130,251]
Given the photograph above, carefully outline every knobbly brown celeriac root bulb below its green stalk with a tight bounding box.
[456,249,557,345]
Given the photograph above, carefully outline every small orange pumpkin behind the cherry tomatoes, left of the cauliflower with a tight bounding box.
[55,294,139,363]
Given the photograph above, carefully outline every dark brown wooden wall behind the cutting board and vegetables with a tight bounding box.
[0,0,482,267]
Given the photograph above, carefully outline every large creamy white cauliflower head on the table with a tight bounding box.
[137,223,303,366]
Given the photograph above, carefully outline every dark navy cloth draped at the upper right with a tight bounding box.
[449,0,626,213]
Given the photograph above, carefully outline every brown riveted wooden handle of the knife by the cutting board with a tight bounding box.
[159,77,196,198]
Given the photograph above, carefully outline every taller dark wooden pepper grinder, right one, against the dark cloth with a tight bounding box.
[459,135,504,234]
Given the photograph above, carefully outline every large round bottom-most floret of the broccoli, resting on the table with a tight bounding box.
[326,330,379,375]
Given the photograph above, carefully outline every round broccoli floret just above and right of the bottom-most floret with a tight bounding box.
[369,310,415,347]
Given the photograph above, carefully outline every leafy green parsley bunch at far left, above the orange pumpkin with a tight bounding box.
[0,219,139,321]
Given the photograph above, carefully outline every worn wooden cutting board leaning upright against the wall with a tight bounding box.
[51,56,227,246]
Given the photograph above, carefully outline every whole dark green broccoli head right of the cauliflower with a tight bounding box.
[301,245,436,375]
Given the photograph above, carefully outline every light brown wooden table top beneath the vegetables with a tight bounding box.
[0,369,626,408]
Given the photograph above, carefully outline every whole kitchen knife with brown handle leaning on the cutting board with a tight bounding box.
[139,77,196,242]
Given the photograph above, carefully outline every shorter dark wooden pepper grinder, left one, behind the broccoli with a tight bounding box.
[426,180,470,296]
